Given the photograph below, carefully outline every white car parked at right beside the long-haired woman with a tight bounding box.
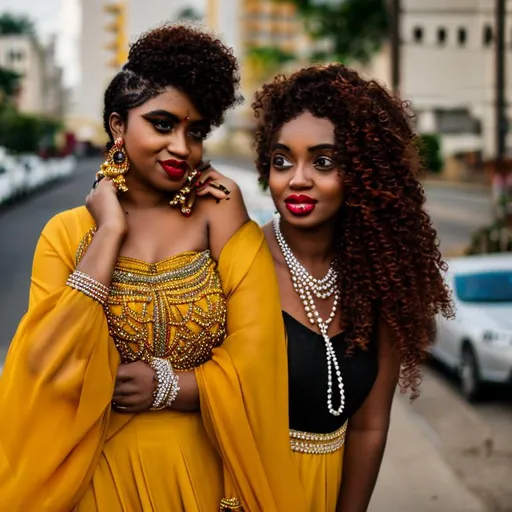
[432,253,512,401]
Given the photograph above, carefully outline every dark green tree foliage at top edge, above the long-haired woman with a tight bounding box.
[275,0,389,63]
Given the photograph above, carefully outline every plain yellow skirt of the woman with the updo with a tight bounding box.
[75,410,224,512]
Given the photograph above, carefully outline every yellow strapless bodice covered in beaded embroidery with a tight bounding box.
[77,230,226,370]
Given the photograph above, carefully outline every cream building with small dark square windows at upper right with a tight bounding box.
[365,0,512,158]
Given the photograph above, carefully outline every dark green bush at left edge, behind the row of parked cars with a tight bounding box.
[0,106,61,153]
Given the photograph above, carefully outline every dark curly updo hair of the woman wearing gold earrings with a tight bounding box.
[103,24,241,145]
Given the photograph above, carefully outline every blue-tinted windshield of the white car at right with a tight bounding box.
[455,270,512,302]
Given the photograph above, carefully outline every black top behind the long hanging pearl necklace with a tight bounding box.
[283,311,378,434]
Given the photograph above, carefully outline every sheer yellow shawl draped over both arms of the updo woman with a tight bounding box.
[0,207,305,512]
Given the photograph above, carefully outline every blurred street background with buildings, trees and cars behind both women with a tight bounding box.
[0,0,512,512]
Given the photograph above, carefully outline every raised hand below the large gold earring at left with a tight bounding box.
[85,179,128,235]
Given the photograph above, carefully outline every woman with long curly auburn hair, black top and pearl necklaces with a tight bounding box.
[253,64,452,512]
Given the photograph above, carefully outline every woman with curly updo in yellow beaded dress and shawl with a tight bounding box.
[0,25,305,512]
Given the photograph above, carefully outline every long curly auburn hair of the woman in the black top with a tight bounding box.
[253,64,453,398]
